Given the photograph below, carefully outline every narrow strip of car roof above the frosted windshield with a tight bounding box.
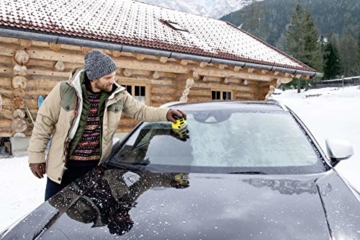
[161,100,288,112]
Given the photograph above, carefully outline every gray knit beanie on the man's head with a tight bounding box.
[84,50,116,80]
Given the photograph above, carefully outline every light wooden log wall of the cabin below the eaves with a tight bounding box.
[0,37,293,137]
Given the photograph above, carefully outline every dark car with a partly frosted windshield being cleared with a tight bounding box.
[0,100,360,240]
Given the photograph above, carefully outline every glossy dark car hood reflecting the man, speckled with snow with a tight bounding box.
[4,168,360,240]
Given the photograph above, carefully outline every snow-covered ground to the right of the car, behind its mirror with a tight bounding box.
[274,86,360,190]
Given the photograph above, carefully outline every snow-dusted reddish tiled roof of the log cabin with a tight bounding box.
[0,0,314,71]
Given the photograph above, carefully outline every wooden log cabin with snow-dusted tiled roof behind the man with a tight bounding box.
[0,0,321,146]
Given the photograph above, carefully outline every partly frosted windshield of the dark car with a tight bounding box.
[109,105,326,174]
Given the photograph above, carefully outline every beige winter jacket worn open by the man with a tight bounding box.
[28,68,169,183]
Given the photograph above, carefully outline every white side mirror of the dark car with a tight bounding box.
[325,139,354,166]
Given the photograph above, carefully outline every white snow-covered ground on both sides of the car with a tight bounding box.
[0,87,360,232]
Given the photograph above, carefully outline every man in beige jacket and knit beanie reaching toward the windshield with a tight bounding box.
[29,50,186,200]
